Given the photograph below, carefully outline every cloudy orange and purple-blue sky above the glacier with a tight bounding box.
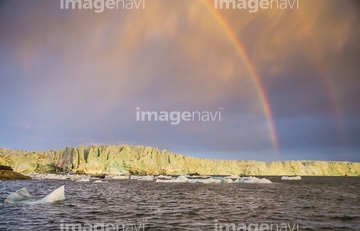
[0,0,360,161]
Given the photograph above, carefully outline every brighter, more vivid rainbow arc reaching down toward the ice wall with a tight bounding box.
[201,0,279,152]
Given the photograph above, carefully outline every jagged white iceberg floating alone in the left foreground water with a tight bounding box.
[4,185,65,204]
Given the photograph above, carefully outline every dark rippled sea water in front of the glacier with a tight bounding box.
[0,176,360,231]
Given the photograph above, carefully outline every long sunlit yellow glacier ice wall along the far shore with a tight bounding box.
[0,145,360,176]
